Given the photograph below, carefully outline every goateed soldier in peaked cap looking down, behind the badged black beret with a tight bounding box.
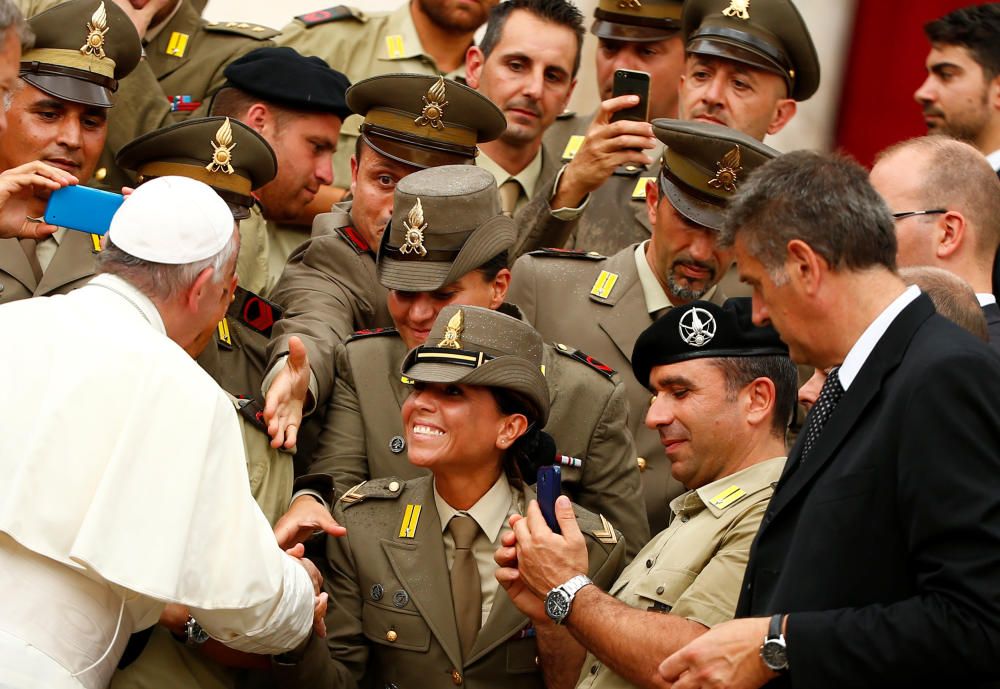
[510,120,776,532]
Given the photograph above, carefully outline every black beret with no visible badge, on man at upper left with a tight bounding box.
[223,47,351,119]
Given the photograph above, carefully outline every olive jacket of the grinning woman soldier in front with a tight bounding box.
[270,476,624,689]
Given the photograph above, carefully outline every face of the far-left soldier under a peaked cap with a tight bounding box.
[0,81,108,183]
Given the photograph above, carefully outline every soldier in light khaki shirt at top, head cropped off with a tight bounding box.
[276,0,496,206]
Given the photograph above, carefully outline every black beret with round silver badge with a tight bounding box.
[632,297,788,387]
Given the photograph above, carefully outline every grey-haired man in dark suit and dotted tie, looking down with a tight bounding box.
[659,151,1000,689]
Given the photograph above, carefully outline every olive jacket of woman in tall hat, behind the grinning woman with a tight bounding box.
[295,330,649,555]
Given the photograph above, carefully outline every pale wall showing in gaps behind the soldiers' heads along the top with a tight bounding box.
[205,0,856,151]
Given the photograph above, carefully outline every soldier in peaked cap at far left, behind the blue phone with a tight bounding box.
[0,0,142,303]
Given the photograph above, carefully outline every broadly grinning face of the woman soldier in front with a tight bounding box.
[403,382,527,476]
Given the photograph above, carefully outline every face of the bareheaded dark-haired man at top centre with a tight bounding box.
[467,10,577,145]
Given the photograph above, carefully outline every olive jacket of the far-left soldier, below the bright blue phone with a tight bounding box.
[0,230,98,304]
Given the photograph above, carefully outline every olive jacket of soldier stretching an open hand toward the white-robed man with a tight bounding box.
[267,201,392,412]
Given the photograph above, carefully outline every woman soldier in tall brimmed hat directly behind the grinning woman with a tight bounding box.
[278,166,649,553]
